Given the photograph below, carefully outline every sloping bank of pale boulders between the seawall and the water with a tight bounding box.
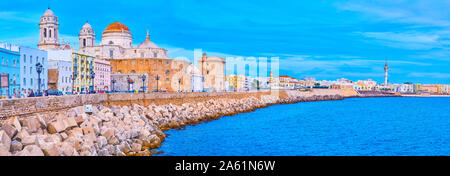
[0,92,342,156]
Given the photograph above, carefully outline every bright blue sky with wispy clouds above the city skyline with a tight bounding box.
[0,0,450,84]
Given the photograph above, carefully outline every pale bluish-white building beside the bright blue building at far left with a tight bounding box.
[20,47,48,92]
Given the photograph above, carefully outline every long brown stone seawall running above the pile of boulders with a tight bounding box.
[0,91,273,119]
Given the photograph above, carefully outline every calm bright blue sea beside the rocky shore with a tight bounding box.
[160,97,450,156]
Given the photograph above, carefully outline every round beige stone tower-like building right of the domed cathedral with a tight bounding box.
[198,53,225,92]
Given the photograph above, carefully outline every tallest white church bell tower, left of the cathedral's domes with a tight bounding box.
[38,8,59,50]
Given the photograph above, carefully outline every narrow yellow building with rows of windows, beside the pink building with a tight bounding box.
[72,50,95,92]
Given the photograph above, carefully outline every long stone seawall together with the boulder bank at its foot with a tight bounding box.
[0,90,384,156]
